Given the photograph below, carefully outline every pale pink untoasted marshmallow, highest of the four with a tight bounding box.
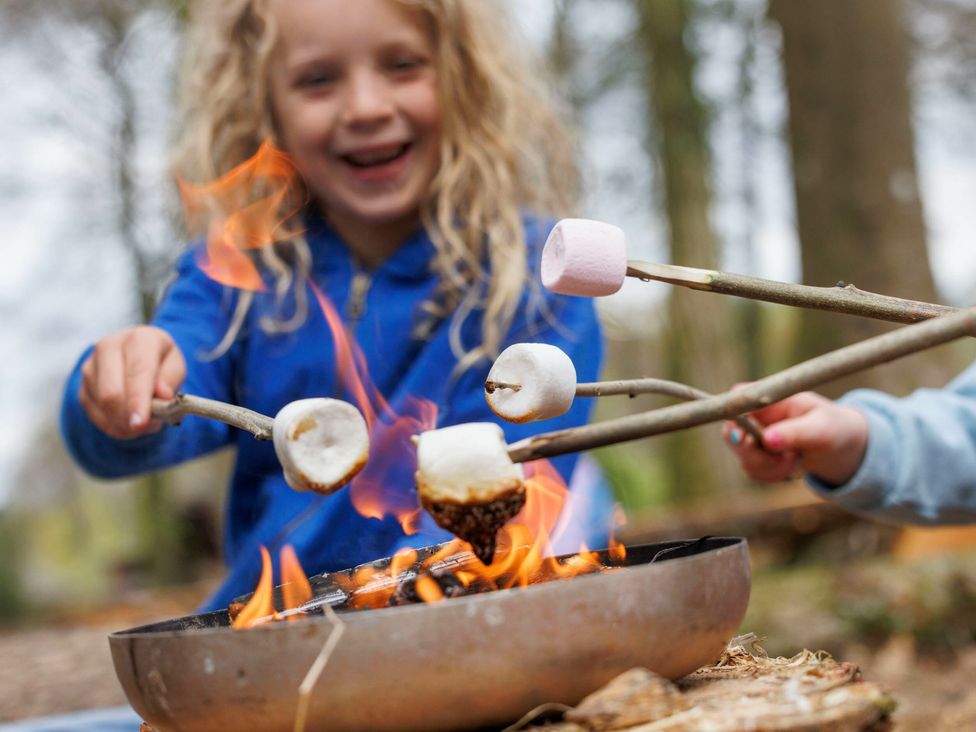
[541,219,627,297]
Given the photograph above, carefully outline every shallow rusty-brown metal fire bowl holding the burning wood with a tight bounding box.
[109,538,750,732]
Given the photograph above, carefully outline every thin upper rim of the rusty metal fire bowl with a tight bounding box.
[108,536,748,641]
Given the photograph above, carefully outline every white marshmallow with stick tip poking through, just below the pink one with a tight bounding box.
[485,343,576,423]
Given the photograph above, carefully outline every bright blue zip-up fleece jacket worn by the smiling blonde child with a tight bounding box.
[61,217,609,609]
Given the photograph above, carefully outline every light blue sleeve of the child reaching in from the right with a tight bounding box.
[808,364,976,525]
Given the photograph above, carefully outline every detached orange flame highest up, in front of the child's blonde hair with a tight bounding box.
[179,142,299,291]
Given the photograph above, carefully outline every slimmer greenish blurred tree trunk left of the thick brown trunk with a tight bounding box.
[635,0,743,497]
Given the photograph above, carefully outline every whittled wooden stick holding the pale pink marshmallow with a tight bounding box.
[627,259,957,323]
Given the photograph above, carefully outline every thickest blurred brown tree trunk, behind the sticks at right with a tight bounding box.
[769,0,947,395]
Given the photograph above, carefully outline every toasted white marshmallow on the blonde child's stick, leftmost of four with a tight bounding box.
[272,399,369,494]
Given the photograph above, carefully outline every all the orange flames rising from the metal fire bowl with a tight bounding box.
[180,142,625,628]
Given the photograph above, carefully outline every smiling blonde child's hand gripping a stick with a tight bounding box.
[79,325,186,440]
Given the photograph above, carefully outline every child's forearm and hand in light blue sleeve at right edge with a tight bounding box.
[723,365,976,525]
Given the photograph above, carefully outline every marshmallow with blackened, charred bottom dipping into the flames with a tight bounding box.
[416,422,525,564]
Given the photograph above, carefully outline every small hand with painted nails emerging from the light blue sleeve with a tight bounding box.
[722,391,868,485]
